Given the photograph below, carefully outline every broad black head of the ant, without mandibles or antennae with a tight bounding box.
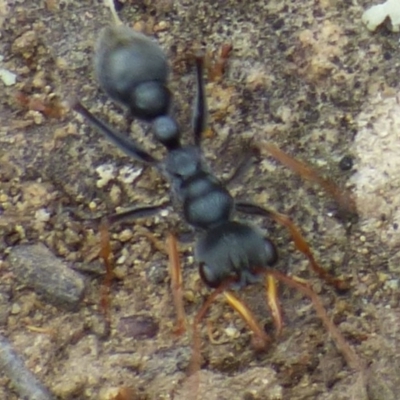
[196,221,278,288]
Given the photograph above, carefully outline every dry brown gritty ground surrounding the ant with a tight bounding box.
[0,0,400,400]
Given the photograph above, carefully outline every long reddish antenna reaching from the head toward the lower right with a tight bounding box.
[265,268,365,371]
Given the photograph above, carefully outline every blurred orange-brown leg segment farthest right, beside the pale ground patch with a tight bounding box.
[258,143,357,219]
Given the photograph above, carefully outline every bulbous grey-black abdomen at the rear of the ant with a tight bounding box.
[94,26,171,120]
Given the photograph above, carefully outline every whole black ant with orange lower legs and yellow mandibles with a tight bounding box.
[72,25,360,374]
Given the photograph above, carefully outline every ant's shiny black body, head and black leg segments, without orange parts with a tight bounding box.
[73,26,277,287]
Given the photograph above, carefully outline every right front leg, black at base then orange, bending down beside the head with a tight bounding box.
[235,202,350,291]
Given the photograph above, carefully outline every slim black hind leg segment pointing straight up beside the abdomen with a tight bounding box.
[193,55,207,147]
